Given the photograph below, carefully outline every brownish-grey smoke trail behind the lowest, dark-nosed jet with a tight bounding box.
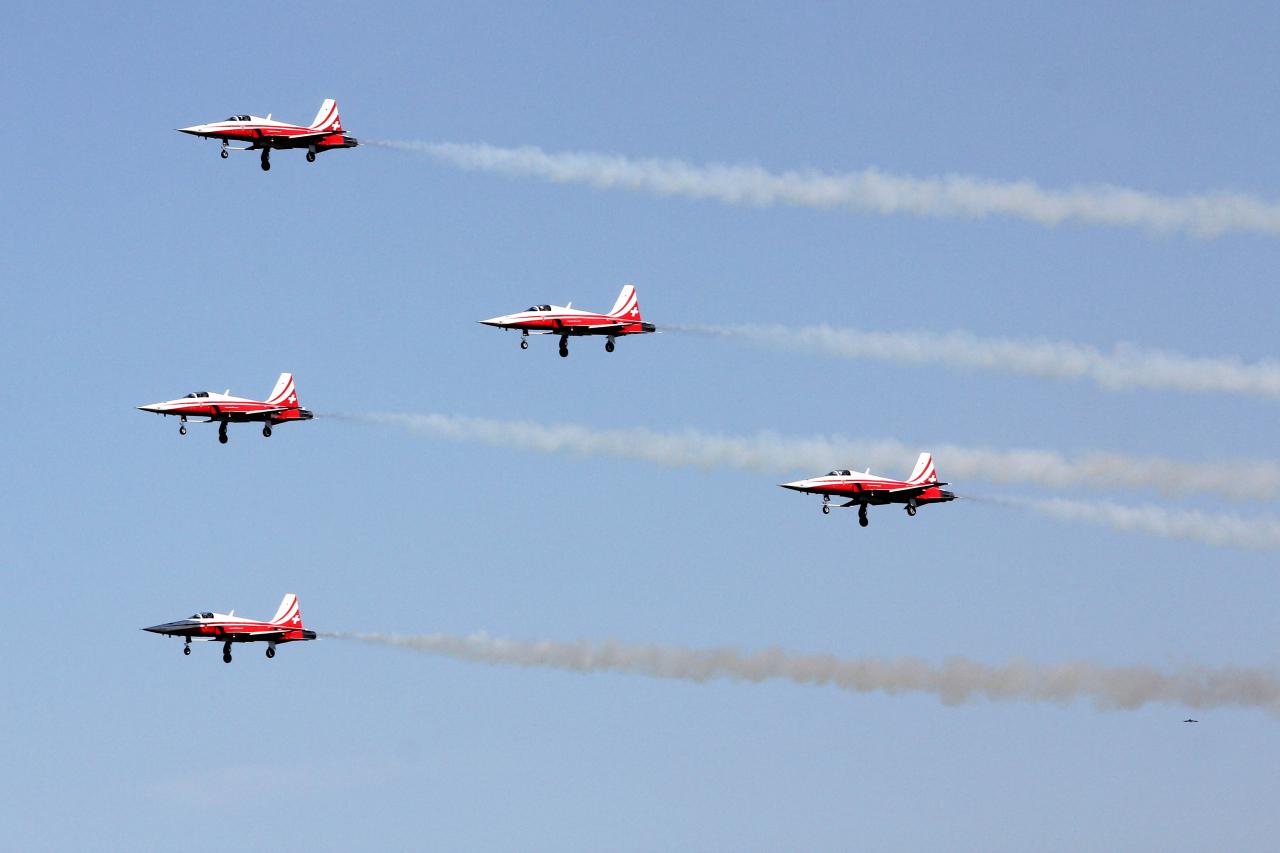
[321,633,1280,715]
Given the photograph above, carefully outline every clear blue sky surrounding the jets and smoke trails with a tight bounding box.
[0,3,1280,850]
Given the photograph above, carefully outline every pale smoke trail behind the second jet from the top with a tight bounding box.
[663,324,1280,400]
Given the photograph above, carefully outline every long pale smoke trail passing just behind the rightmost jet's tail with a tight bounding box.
[330,412,1280,501]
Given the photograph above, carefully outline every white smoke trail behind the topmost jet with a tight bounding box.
[369,140,1280,237]
